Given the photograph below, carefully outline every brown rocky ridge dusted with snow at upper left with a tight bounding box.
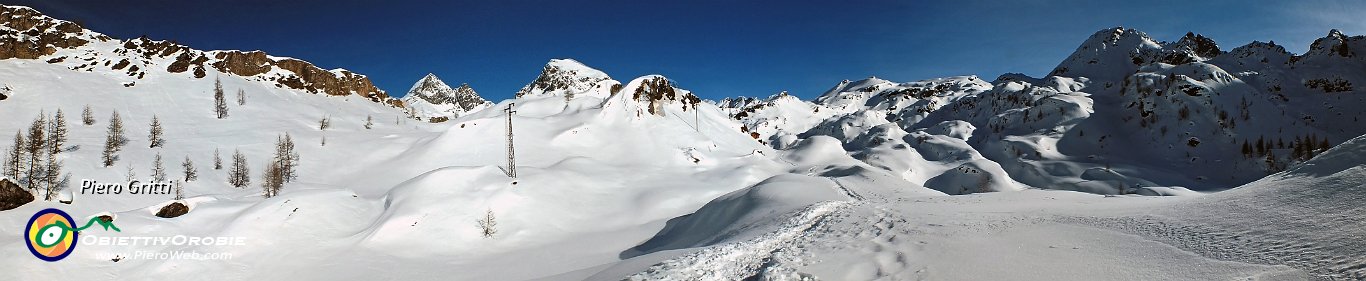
[0,5,402,106]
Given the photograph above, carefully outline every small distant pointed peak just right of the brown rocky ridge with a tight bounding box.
[403,74,493,120]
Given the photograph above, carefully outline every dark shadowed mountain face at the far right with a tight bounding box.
[1043,30,1366,187]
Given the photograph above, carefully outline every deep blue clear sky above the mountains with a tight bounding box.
[0,0,1366,100]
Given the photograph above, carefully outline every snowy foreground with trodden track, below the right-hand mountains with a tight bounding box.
[598,128,1366,280]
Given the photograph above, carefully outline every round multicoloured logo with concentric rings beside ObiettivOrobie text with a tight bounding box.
[23,209,79,262]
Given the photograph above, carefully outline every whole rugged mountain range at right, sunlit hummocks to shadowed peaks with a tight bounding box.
[716,27,1366,194]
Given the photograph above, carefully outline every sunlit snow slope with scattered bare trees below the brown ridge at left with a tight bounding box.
[0,53,415,210]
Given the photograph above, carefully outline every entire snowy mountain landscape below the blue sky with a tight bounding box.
[0,5,1366,281]
